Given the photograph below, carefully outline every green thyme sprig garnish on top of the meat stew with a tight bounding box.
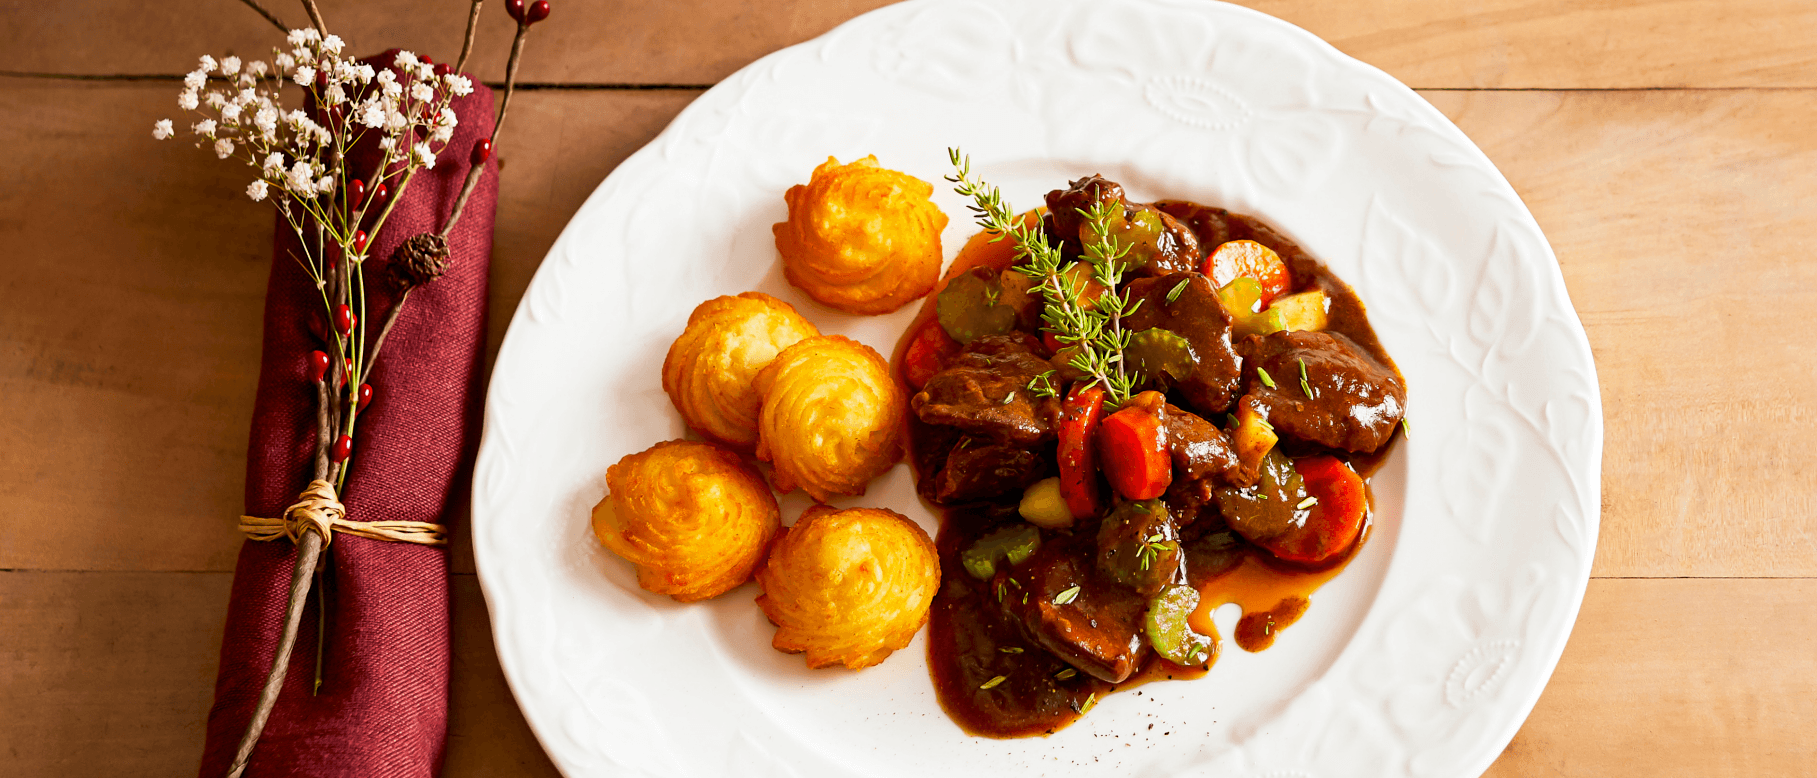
[947,149,1141,407]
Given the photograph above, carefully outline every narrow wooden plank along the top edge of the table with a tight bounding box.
[0,0,1817,89]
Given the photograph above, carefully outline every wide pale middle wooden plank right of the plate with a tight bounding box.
[1428,91,1817,576]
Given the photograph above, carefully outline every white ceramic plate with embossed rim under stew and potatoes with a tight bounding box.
[474,0,1603,778]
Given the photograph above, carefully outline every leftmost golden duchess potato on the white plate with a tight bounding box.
[592,440,781,602]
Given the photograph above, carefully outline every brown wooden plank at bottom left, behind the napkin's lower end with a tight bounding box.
[0,571,556,778]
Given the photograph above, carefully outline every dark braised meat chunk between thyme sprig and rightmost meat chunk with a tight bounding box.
[1123,273,1243,414]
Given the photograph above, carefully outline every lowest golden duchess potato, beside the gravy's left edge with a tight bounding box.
[758,505,939,671]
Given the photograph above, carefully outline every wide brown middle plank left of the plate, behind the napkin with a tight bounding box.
[0,80,698,571]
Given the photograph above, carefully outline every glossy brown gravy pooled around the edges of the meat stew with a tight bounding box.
[890,202,1403,738]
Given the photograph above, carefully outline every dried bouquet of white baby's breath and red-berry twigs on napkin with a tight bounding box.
[153,15,505,776]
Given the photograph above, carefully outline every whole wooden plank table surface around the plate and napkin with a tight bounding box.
[0,0,1817,776]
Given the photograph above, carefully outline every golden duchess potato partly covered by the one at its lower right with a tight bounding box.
[663,293,819,453]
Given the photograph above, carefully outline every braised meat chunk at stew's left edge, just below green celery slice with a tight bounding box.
[909,333,1059,445]
